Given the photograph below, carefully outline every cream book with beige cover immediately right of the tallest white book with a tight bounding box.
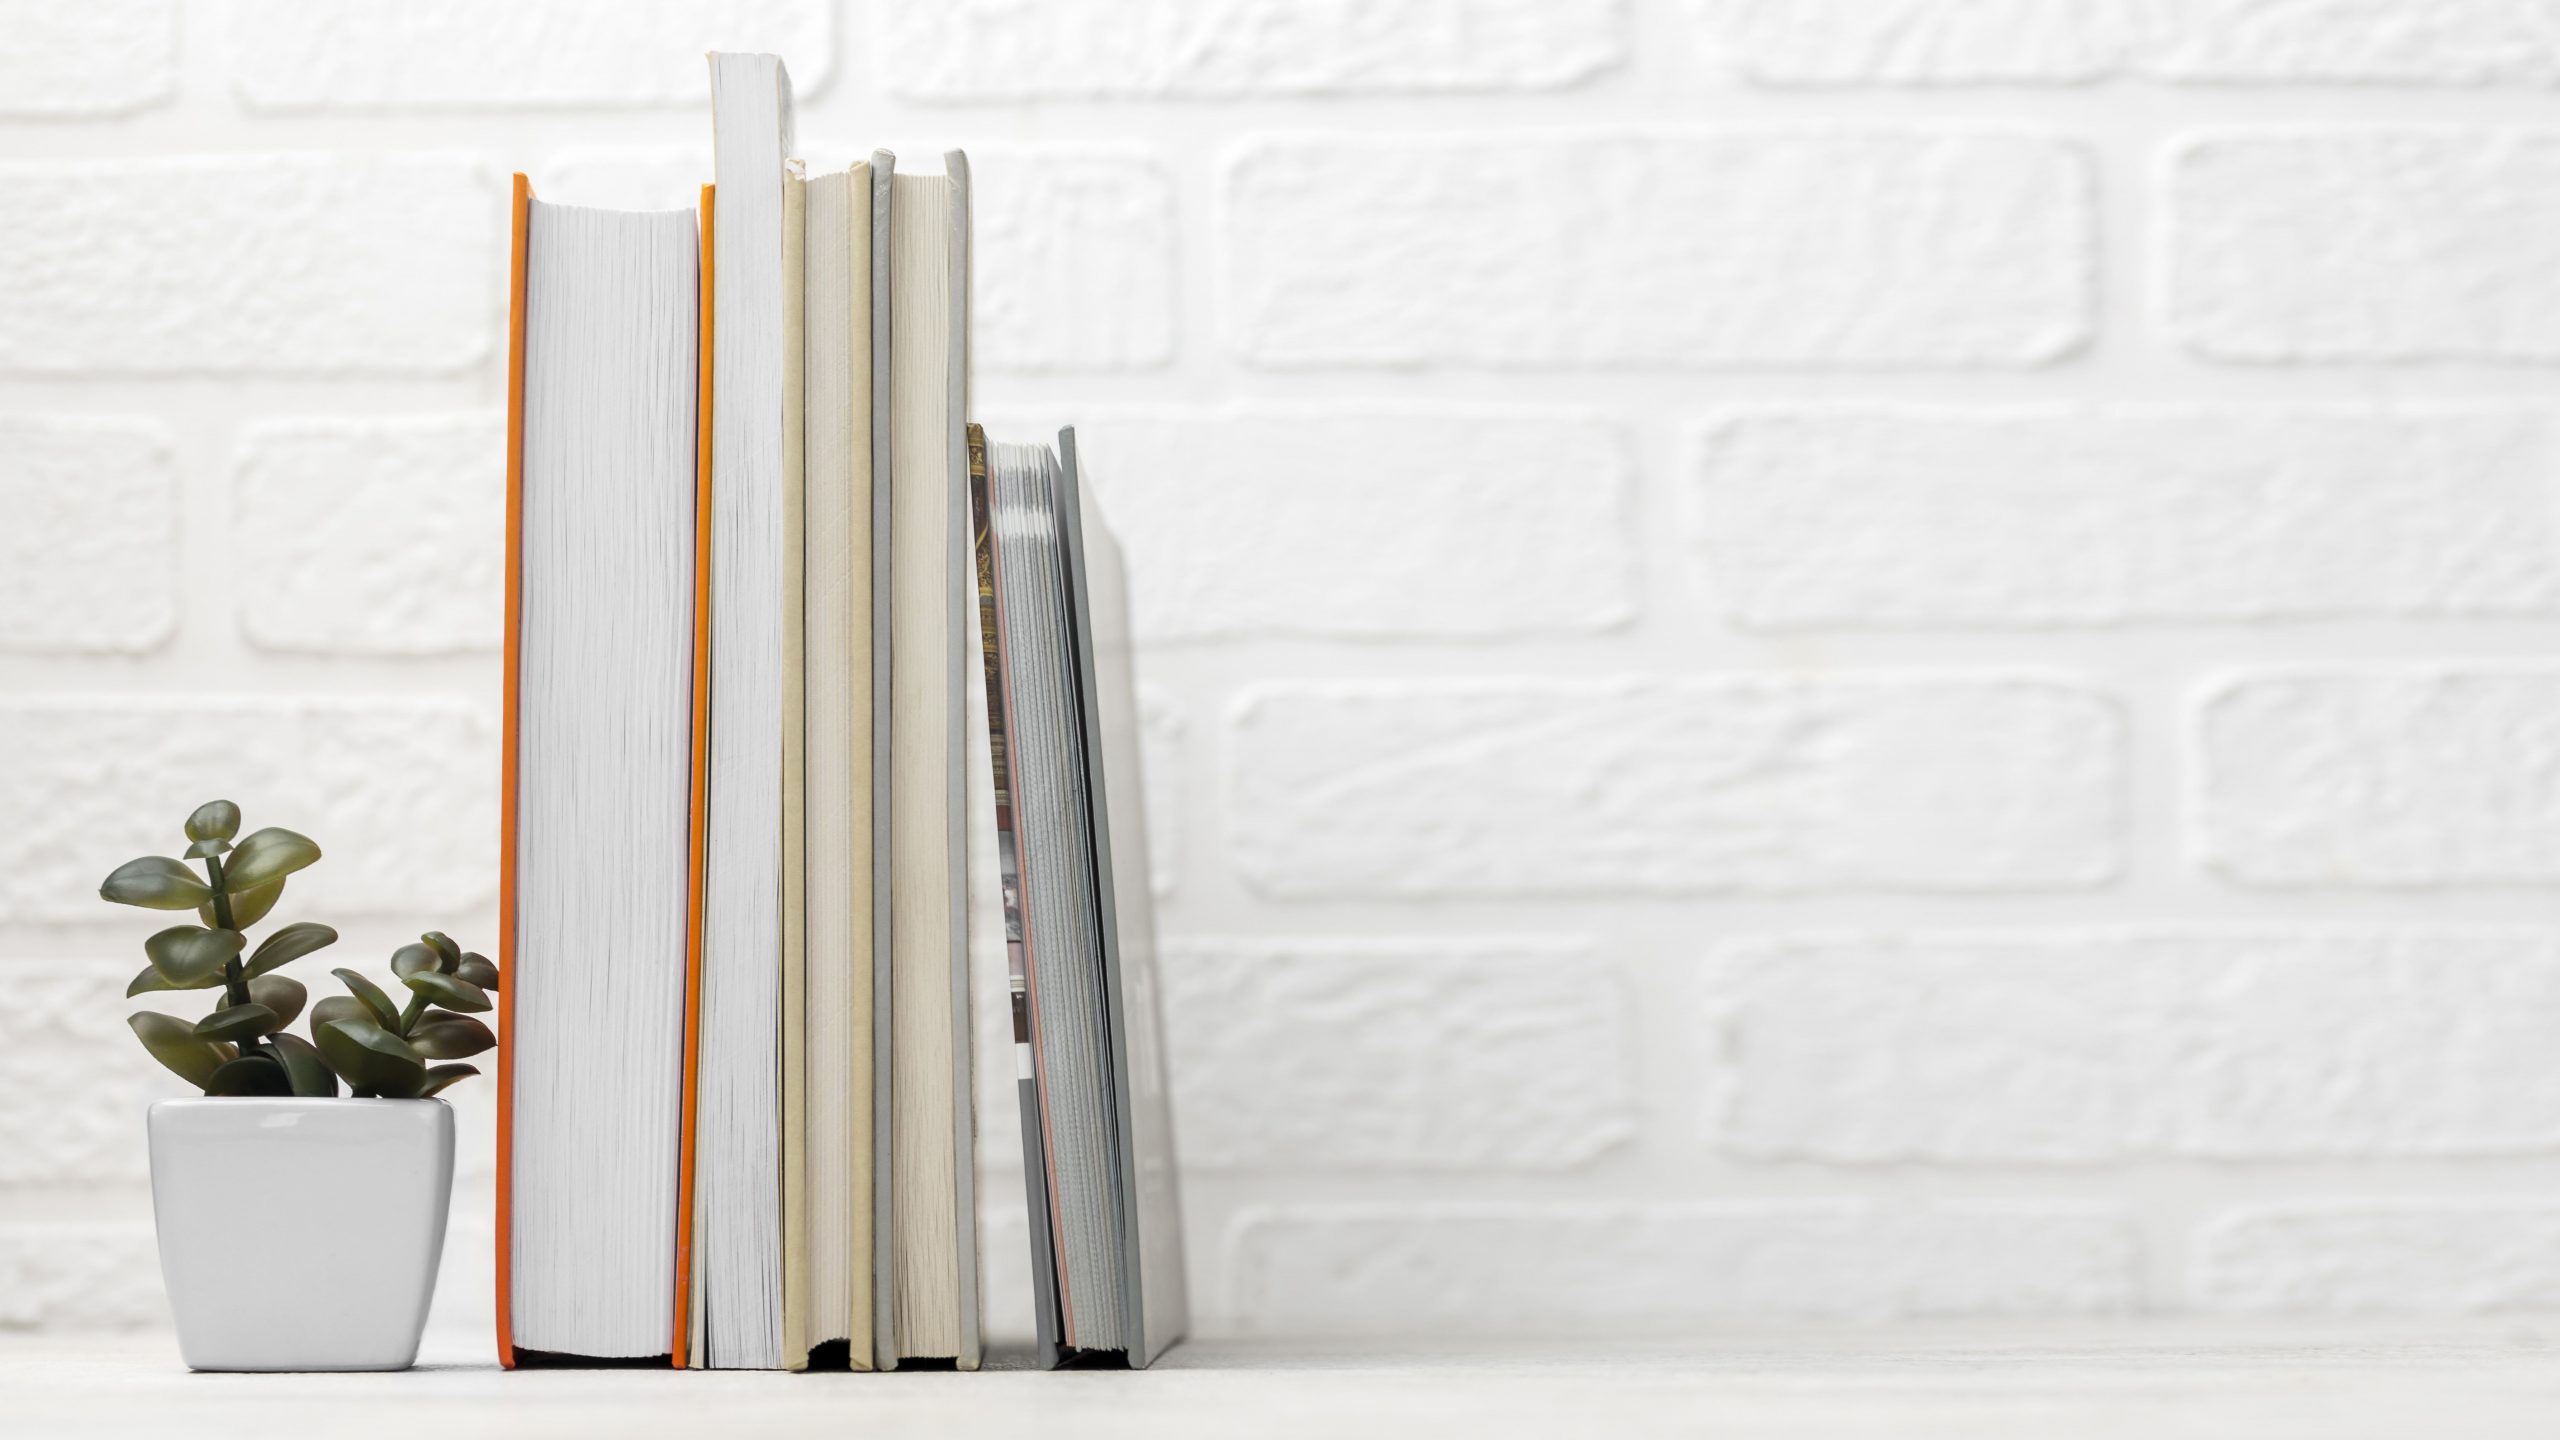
[801,164,873,1371]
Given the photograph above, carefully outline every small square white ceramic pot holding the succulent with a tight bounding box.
[151,1099,453,1371]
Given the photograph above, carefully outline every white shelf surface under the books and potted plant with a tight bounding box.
[0,1320,2560,1440]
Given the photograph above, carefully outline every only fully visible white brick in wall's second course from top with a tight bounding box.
[1219,131,2094,369]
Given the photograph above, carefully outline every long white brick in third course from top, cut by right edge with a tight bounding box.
[1690,407,2560,628]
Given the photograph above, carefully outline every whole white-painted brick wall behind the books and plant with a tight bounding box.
[15,0,2560,1332]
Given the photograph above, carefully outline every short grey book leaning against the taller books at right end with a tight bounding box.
[978,430,1188,1368]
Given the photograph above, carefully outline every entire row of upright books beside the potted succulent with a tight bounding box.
[497,54,1185,1368]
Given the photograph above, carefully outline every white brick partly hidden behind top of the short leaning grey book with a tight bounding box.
[1070,407,1638,643]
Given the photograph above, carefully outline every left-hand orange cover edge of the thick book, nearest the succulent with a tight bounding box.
[497,174,532,1371]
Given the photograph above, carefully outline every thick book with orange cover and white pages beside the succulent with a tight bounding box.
[497,174,712,1368]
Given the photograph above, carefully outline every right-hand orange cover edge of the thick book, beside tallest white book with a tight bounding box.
[673,184,712,1371]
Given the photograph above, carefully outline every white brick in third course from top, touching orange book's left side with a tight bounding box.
[233,415,507,656]
